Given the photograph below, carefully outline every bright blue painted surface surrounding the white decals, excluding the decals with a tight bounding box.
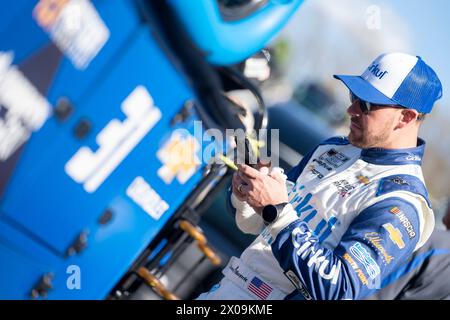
[0,0,209,299]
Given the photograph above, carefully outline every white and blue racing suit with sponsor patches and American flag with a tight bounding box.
[199,137,434,300]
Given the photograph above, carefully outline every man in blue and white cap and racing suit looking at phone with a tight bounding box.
[199,53,442,299]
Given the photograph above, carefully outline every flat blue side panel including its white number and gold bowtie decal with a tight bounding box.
[0,1,211,299]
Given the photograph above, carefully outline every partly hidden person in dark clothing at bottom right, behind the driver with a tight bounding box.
[370,203,450,300]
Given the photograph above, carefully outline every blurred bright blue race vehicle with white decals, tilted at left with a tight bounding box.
[0,0,302,299]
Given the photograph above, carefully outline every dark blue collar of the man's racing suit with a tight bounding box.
[361,138,425,166]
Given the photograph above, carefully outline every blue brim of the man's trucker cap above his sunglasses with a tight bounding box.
[334,74,397,105]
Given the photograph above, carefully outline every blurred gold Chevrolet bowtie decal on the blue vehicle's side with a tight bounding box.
[156,133,200,184]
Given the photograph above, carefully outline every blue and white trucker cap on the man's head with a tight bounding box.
[334,52,442,113]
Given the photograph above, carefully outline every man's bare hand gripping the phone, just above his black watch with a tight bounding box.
[233,164,288,212]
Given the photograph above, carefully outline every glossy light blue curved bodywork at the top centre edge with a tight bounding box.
[169,0,303,65]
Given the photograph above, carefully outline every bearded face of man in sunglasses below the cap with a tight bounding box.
[347,100,400,149]
